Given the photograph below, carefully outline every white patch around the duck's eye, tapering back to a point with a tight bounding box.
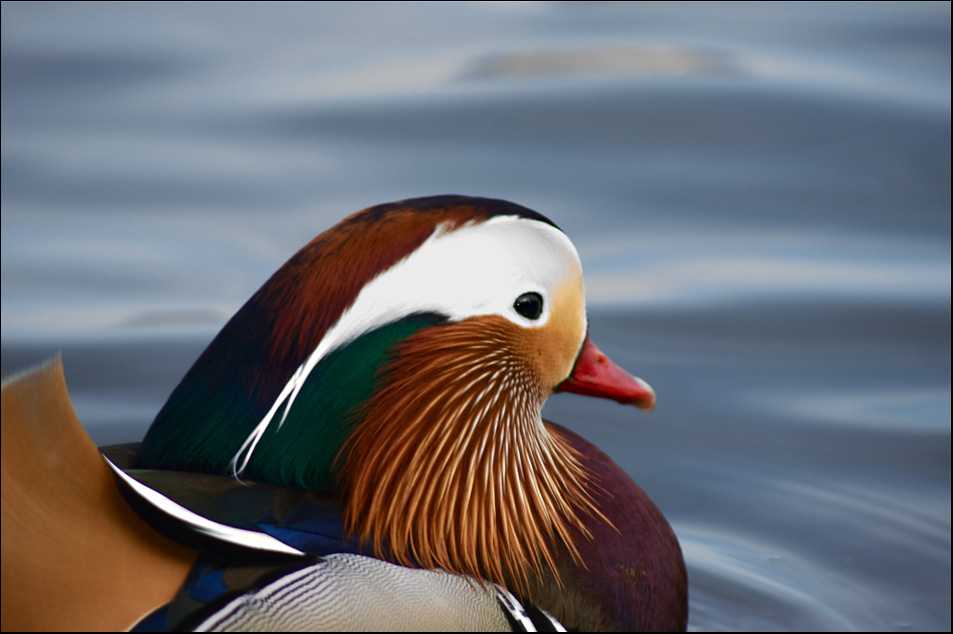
[232,216,584,475]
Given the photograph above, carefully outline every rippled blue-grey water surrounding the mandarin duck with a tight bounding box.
[0,2,951,631]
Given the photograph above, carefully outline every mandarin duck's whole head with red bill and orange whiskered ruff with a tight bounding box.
[140,196,655,585]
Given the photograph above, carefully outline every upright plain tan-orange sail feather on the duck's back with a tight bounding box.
[2,357,196,631]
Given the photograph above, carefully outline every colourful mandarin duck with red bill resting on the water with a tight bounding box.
[3,196,687,631]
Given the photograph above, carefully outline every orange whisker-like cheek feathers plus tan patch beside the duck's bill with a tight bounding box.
[340,251,599,588]
